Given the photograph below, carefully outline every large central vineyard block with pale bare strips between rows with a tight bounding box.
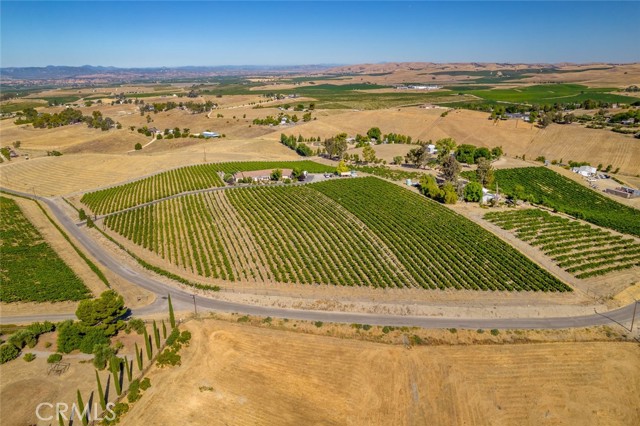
[105,178,571,292]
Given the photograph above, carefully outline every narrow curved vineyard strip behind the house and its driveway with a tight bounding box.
[80,161,334,215]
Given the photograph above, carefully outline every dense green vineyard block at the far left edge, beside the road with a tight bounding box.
[0,197,91,303]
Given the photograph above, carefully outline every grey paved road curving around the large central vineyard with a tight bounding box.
[0,188,640,329]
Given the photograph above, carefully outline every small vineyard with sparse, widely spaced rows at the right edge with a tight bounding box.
[484,209,640,279]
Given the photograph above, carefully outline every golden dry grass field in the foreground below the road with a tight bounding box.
[122,321,640,425]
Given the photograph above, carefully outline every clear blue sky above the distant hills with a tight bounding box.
[0,0,640,67]
